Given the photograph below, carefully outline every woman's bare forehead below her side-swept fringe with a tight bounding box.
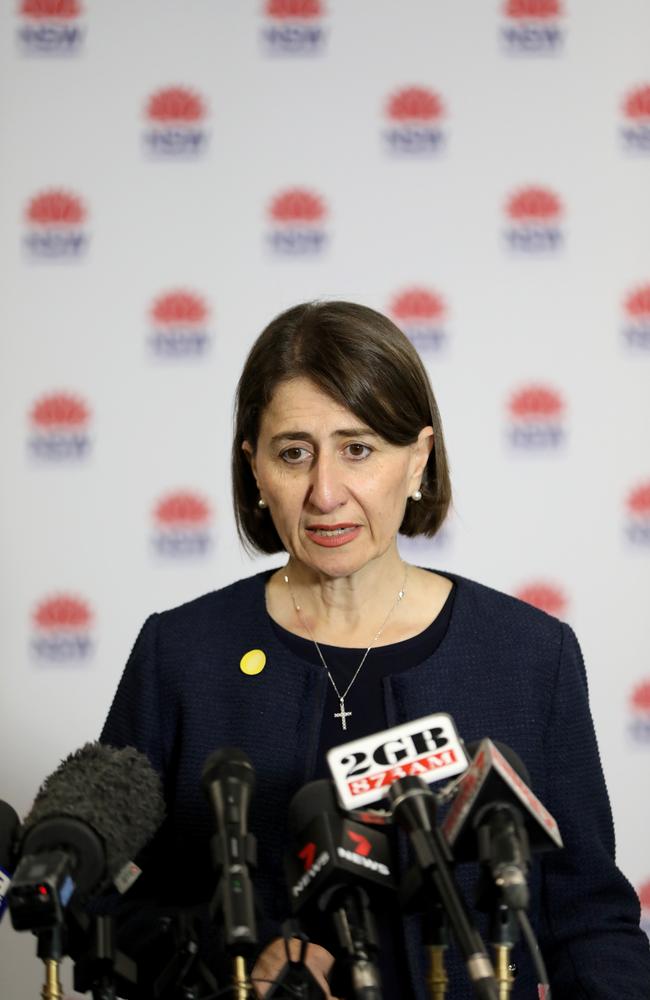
[260,378,364,433]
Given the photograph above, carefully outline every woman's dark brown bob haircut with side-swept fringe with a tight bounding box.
[232,302,451,553]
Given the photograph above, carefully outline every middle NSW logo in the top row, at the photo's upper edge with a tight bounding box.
[261,0,327,56]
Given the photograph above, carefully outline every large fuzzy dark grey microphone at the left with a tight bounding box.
[8,743,164,932]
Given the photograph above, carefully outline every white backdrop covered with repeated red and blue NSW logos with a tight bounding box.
[0,0,650,996]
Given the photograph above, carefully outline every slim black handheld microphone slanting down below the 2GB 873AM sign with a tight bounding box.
[388,777,499,1000]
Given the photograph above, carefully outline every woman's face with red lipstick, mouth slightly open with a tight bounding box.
[243,378,433,577]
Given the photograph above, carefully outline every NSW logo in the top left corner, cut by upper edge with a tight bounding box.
[17,0,86,56]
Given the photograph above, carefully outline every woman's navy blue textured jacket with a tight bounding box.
[102,573,650,1000]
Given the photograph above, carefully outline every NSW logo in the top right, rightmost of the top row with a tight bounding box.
[500,0,564,56]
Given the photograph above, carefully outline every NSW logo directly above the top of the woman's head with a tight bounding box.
[267,187,327,257]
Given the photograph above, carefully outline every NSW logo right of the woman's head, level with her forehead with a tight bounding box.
[508,385,565,451]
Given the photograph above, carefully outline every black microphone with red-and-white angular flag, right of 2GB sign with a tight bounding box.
[442,739,562,910]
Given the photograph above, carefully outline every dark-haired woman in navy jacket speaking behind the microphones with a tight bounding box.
[102,302,650,1000]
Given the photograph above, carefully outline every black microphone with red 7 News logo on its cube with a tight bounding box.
[285,779,394,1000]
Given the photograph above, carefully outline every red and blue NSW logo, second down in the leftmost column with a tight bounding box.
[23,188,89,261]
